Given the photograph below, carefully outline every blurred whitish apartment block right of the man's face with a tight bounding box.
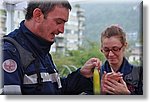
[51,4,85,54]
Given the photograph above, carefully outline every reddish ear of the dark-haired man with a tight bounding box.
[33,8,44,23]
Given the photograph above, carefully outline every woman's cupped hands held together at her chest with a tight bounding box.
[102,73,130,95]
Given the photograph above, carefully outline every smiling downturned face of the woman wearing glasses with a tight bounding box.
[101,36,125,66]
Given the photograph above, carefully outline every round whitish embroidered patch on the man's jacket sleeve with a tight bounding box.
[2,59,17,73]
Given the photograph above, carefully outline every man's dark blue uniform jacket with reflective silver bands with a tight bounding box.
[2,21,92,95]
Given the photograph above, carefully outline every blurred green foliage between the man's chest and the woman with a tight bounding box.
[52,42,105,76]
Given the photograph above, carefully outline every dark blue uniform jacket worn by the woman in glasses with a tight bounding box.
[101,58,143,95]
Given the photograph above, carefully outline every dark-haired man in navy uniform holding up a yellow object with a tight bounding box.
[2,0,100,95]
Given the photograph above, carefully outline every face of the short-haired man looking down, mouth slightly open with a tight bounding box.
[38,6,69,42]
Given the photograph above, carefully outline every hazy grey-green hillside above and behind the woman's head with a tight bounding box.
[72,3,142,42]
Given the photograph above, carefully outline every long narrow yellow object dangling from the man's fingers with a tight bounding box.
[93,68,100,95]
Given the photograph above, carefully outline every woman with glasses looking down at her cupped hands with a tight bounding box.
[101,25,143,95]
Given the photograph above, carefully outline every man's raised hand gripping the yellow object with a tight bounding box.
[80,58,101,78]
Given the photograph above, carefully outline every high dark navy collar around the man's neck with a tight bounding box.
[20,20,53,55]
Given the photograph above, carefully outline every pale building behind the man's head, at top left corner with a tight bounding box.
[0,0,27,36]
